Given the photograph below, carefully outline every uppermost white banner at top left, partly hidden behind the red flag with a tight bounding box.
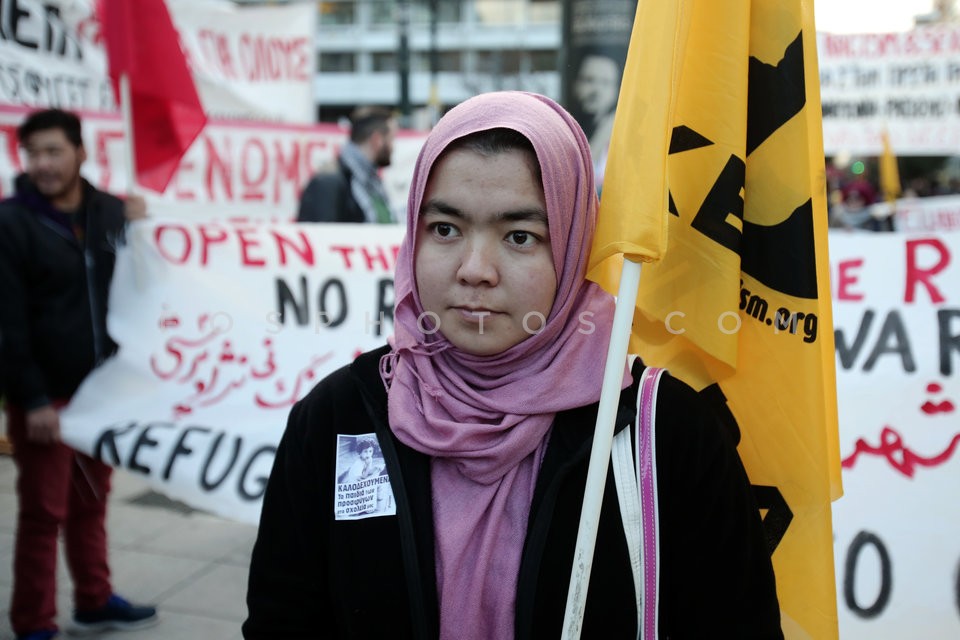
[0,0,317,123]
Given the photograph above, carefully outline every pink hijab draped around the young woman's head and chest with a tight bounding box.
[381,92,630,638]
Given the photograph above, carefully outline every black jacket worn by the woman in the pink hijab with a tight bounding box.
[243,348,782,640]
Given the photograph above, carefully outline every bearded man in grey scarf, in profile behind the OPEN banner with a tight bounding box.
[297,107,397,224]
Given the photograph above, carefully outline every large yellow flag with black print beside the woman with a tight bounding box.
[591,0,841,640]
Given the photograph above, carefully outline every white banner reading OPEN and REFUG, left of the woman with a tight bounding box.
[63,219,403,523]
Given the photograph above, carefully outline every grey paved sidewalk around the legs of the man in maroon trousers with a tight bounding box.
[0,455,256,640]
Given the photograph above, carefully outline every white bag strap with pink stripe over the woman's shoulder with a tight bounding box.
[611,362,664,640]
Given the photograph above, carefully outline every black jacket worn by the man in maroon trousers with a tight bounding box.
[0,175,125,409]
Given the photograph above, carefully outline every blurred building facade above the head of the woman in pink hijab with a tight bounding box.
[314,0,561,129]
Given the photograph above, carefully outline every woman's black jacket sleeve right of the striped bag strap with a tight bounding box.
[656,376,783,639]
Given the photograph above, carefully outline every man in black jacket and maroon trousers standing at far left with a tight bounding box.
[0,109,157,639]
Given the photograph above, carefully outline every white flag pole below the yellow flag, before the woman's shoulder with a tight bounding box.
[561,258,640,640]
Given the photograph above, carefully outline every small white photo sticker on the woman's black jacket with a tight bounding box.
[333,433,397,520]
